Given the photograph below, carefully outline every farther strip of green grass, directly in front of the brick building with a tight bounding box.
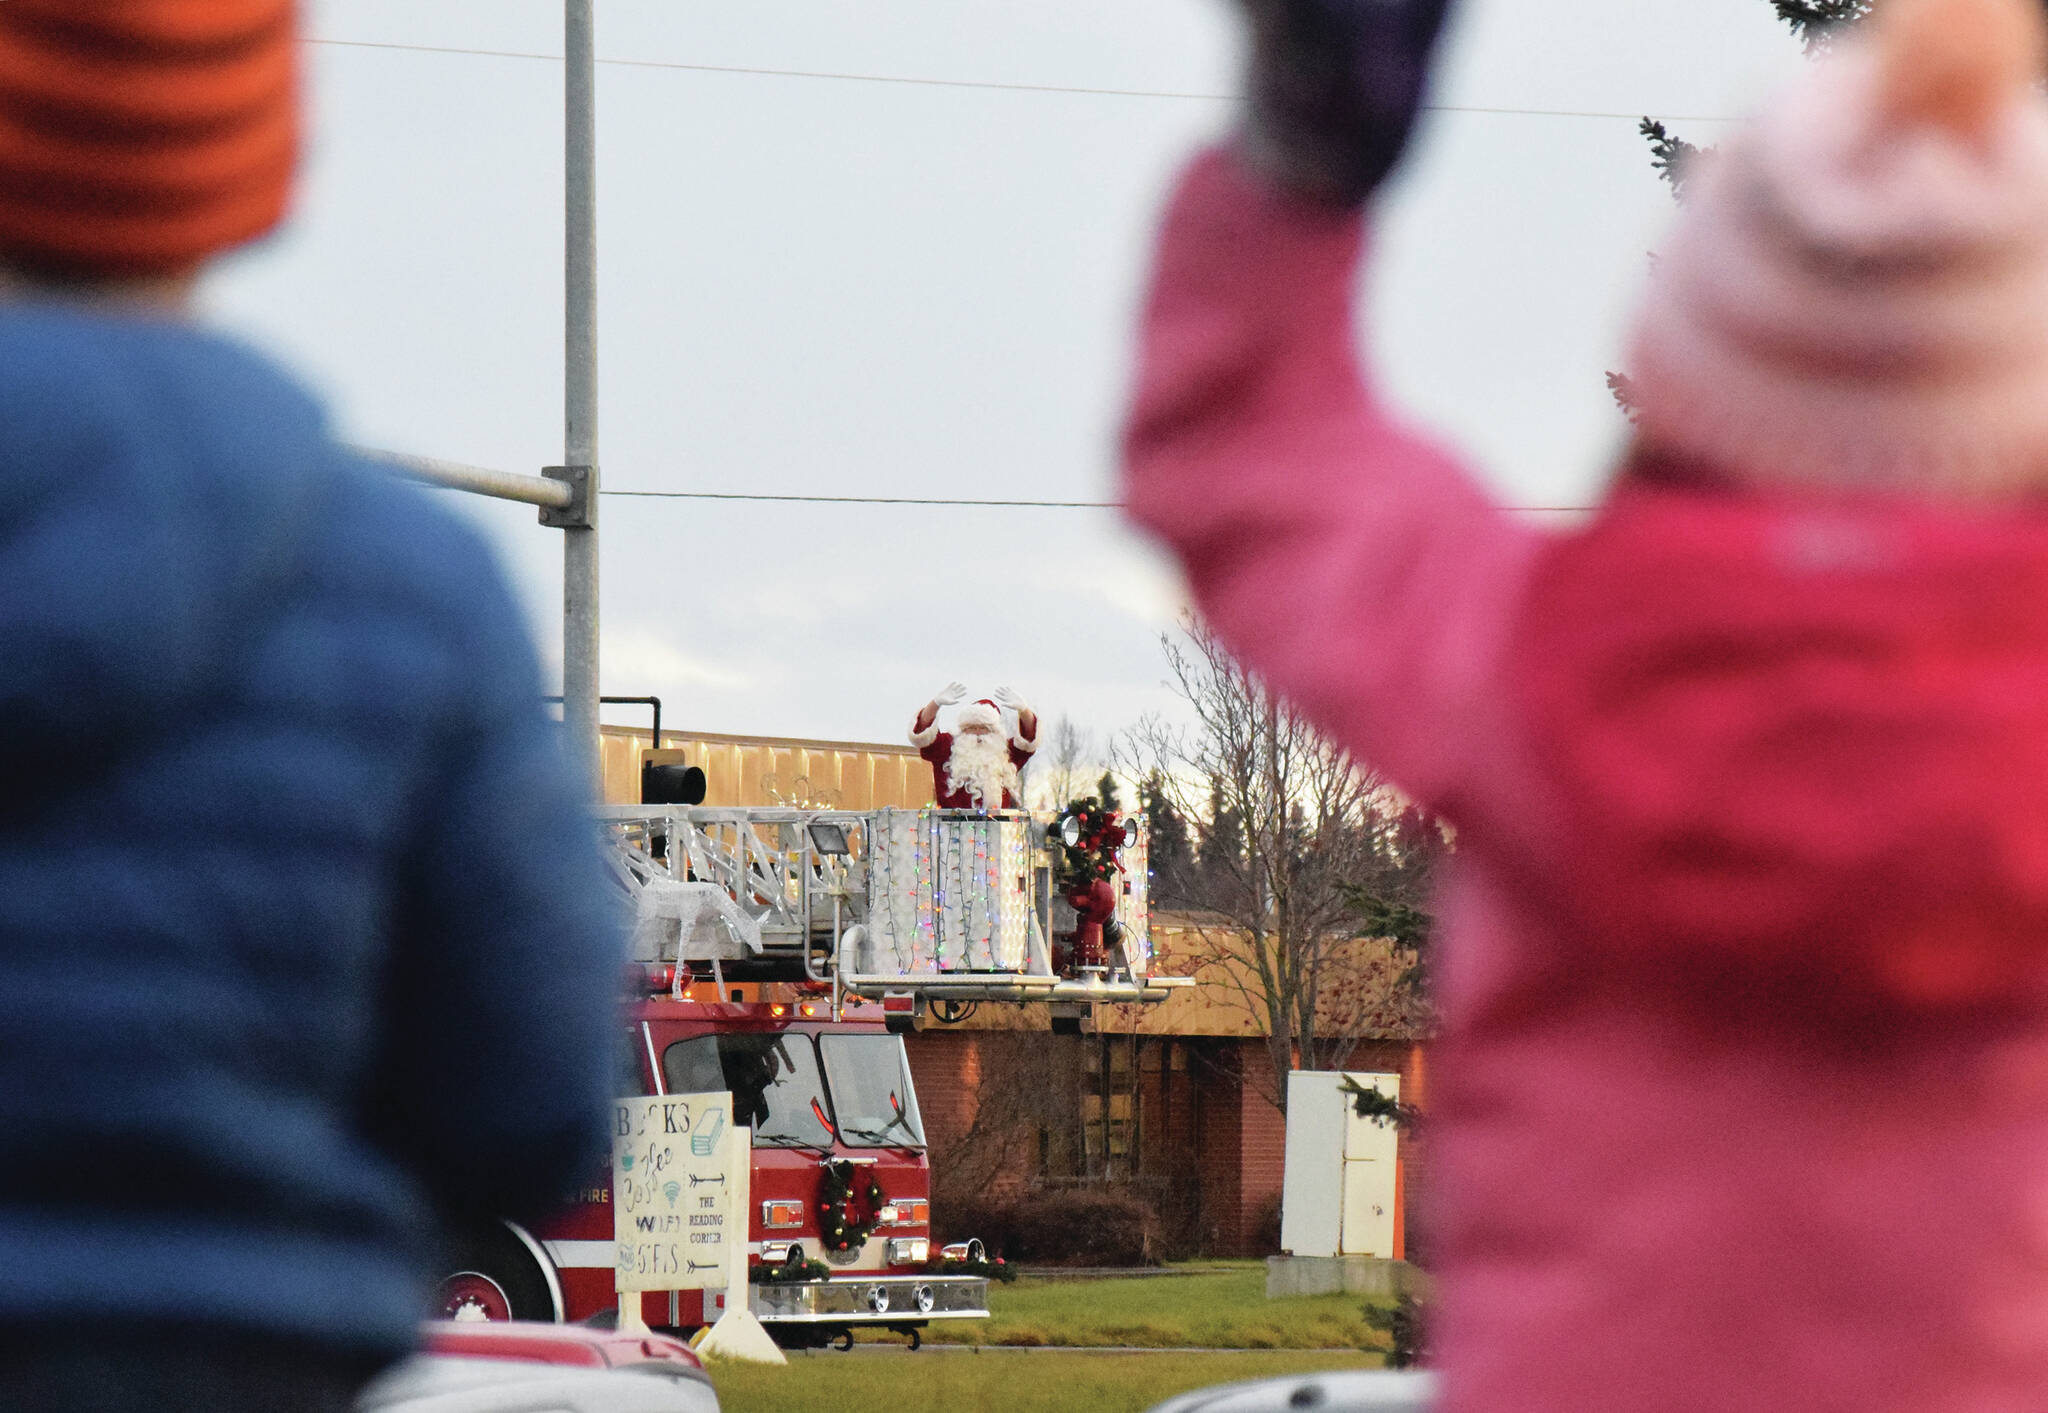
[913,1261,1386,1350]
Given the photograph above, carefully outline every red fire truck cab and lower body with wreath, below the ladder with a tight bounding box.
[442,977,989,1345]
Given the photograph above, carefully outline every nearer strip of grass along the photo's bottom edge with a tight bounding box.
[711,1343,1380,1413]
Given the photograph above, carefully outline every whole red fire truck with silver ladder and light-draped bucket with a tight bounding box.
[442,794,1188,1347]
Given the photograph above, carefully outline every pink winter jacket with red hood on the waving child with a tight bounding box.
[1126,154,2048,1413]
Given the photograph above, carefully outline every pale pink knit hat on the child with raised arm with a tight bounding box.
[1628,0,2048,498]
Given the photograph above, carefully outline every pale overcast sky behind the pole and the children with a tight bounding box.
[207,0,1800,741]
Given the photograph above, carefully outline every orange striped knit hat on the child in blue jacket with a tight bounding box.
[0,0,299,279]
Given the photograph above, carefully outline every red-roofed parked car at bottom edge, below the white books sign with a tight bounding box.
[356,1321,719,1413]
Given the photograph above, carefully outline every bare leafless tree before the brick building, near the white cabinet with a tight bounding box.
[1118,623,1423,1110]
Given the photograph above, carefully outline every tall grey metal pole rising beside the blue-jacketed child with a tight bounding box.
[541,0,602,788]
